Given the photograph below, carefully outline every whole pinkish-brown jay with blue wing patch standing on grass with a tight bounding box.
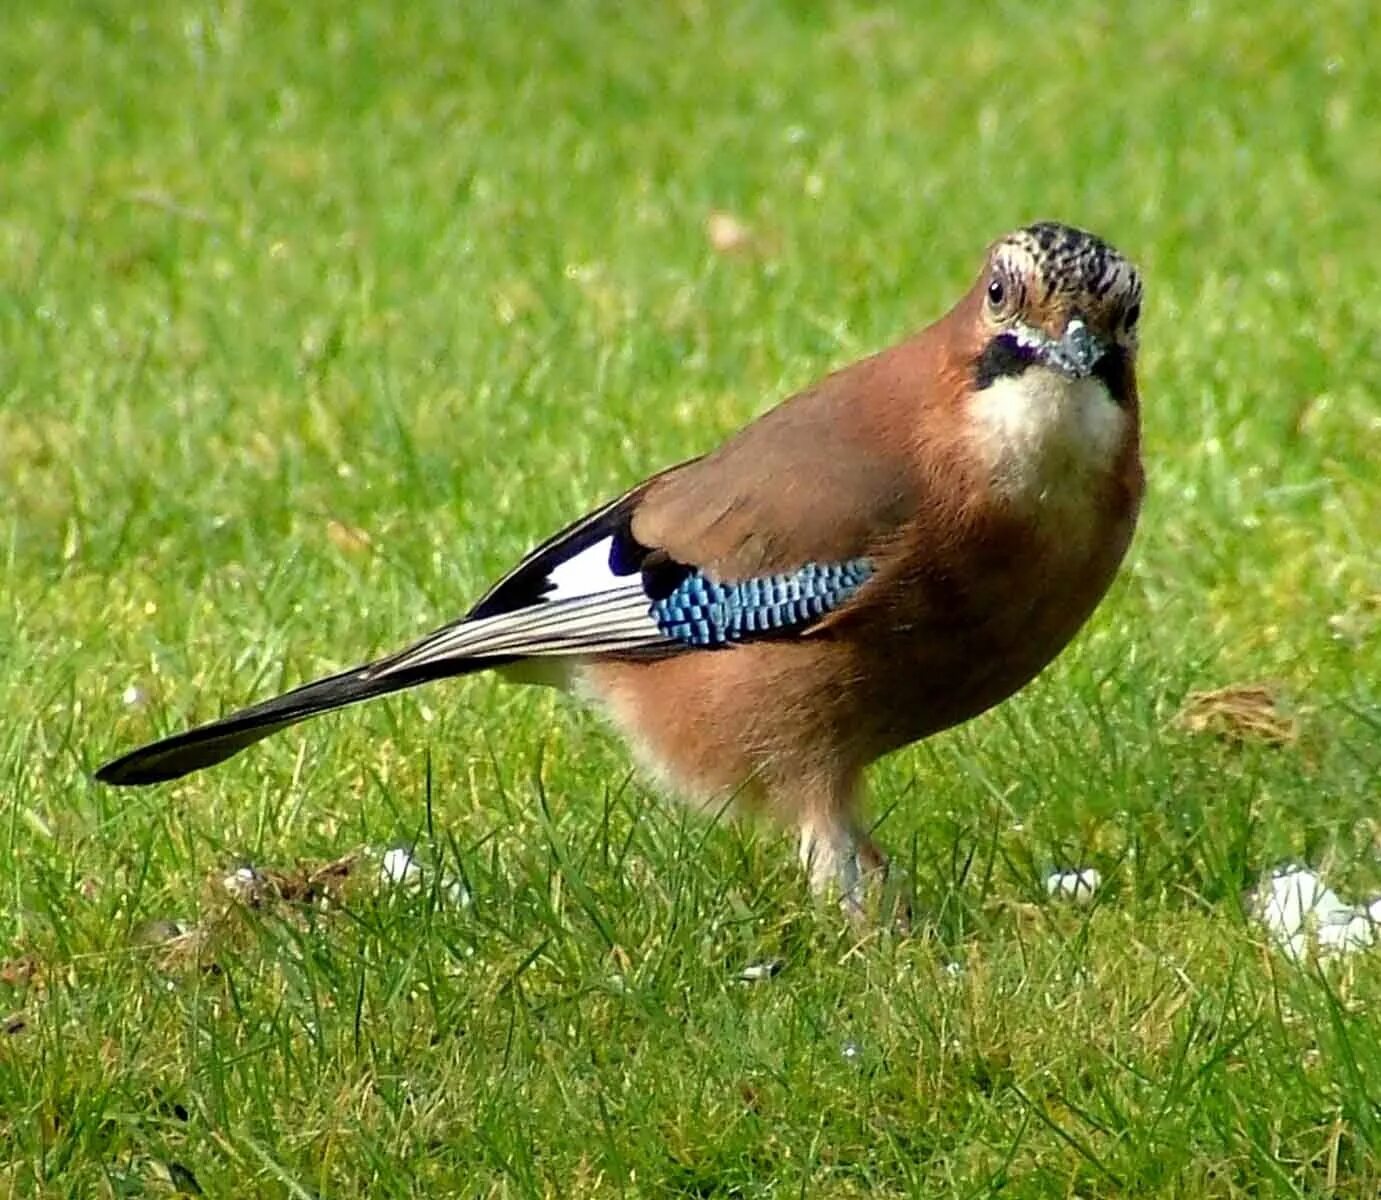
[97,222,1142,914]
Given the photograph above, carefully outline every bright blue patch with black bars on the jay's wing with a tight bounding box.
[650,558,873,646]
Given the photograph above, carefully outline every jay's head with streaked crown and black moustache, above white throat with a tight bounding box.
[968,221,1141,406]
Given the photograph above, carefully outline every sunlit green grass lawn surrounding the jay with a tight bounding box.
[0,0,1381,1200]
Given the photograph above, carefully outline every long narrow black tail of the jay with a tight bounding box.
[95,646,491,786]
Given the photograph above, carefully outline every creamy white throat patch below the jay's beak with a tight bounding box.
[971,366,1130,508]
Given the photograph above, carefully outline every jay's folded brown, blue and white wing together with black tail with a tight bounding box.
[97,356,913,784]
